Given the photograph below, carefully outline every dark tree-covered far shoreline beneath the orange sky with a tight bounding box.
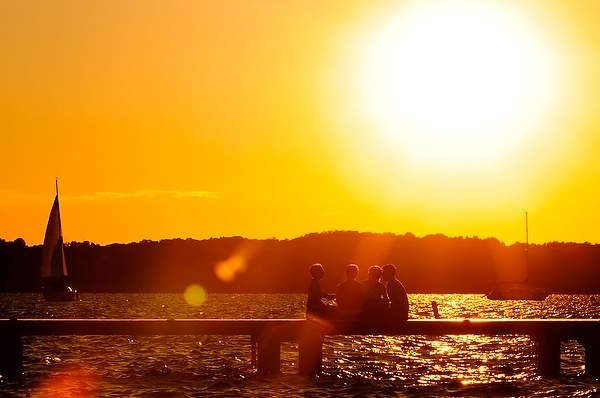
[0,231,600,293]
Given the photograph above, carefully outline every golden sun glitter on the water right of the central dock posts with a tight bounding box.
[318,294,584,386]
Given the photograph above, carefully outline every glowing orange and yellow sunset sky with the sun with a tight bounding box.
[0,0,600,245]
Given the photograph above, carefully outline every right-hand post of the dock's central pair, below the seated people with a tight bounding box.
[298,322,325,376]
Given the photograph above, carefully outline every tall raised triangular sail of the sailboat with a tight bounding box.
[41,194,67,278]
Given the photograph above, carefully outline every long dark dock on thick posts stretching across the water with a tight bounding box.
[0,319,600,377]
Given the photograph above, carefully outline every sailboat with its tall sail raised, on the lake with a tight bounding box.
[40,180,78,301]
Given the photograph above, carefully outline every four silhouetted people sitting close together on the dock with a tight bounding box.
[306,263,408,321]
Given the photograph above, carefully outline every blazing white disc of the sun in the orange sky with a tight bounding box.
[353,0,557,169]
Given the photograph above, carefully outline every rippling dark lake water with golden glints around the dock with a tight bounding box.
[0,294,600,397]
